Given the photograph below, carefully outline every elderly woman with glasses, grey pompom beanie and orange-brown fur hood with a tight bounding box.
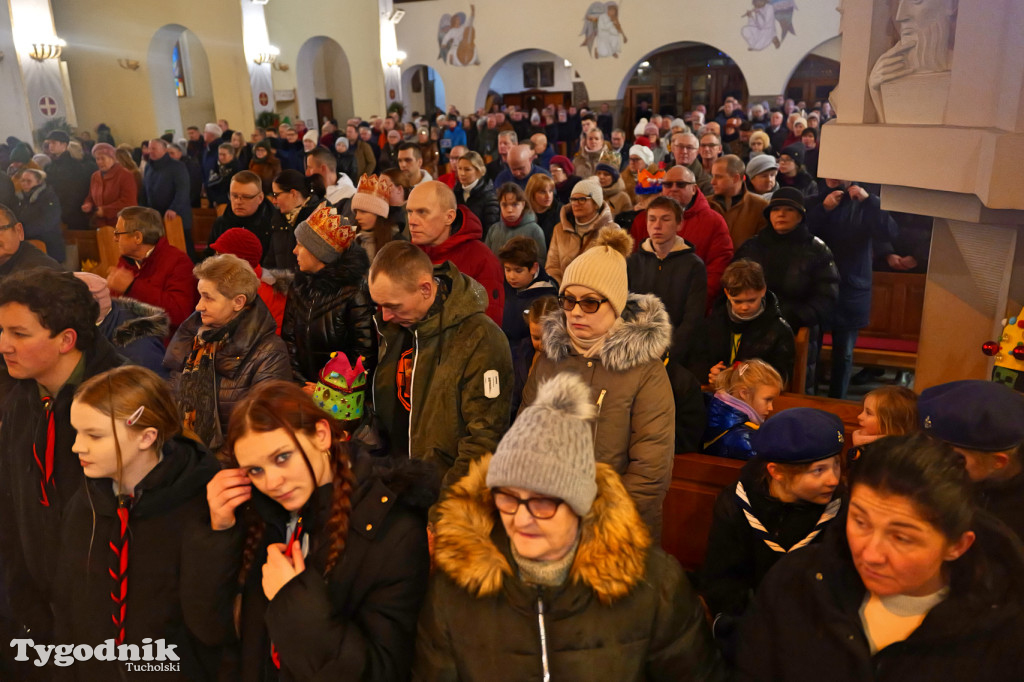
[413,370,723,682]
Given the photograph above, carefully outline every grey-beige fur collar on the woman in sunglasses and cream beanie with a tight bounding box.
[541,294,672,372]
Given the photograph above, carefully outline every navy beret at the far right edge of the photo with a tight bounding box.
[918,379,1024,453]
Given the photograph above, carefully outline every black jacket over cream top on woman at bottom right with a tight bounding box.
[735,512,1024,682]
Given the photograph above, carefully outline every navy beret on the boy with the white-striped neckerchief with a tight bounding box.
[751,408,843,464]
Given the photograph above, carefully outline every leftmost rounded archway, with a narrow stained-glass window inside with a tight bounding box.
[146,24,217,138]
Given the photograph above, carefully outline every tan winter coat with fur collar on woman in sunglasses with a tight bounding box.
[519,294,676,544]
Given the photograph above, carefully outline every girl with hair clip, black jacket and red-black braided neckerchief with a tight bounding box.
[57,366,219,681]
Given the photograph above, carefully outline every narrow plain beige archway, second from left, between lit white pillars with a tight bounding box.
[295,36,355,129]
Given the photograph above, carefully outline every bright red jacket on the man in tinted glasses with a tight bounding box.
[630,191,733,311]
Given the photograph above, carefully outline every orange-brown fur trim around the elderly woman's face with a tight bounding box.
[434,455,650,604]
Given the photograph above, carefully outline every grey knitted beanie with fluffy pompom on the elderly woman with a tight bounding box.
[487,372,597,517]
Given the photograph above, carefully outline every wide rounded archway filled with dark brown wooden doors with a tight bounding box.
[618,41,748,127]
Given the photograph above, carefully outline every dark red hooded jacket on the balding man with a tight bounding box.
[420,206,505,327]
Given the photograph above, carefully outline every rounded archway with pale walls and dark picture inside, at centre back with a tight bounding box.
[475,49,588,111]
